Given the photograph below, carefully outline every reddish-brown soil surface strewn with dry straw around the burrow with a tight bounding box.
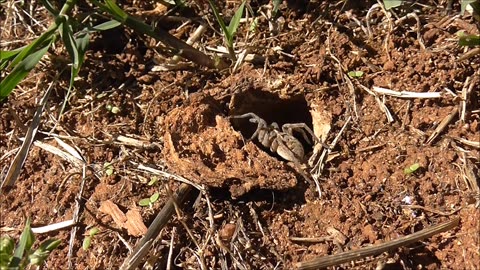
[0,1,480,269]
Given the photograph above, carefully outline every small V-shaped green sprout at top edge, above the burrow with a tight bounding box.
[208,0,245,60]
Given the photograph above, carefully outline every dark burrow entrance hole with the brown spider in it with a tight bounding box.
[229,90,318,163]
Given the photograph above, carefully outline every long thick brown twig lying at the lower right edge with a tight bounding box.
[296,217,460,270]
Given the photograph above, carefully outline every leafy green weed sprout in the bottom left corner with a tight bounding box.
[0,219,61,270]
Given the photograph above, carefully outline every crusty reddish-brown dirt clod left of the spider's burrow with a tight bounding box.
[163,94,297,197]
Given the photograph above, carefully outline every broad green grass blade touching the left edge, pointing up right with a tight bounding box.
[0,44,50,100]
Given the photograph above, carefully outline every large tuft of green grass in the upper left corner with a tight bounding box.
[0,0,222,101]
